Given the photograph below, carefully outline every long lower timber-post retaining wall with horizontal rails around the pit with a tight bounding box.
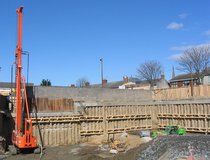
[33,102,210,145]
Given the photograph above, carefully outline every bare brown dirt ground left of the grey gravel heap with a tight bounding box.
[0,134,146,160]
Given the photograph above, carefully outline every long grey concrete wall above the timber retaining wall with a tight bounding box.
[34,86,152,102]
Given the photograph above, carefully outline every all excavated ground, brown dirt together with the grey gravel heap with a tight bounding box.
[0,135,210,160]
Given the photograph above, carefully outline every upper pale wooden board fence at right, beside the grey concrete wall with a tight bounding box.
[153,85,210,100]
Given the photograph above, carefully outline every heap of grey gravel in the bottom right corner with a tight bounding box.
[138,135,210,160]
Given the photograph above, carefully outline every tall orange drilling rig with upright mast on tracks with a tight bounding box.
[10,6,39,154]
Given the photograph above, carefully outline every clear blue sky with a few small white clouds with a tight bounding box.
[0,0,210,86]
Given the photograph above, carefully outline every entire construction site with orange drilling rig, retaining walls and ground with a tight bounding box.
[0,2,210,160]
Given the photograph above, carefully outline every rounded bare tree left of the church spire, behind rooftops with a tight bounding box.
[137,60,162,87]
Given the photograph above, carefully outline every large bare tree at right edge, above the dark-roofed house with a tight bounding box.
[177,46,210,84]
